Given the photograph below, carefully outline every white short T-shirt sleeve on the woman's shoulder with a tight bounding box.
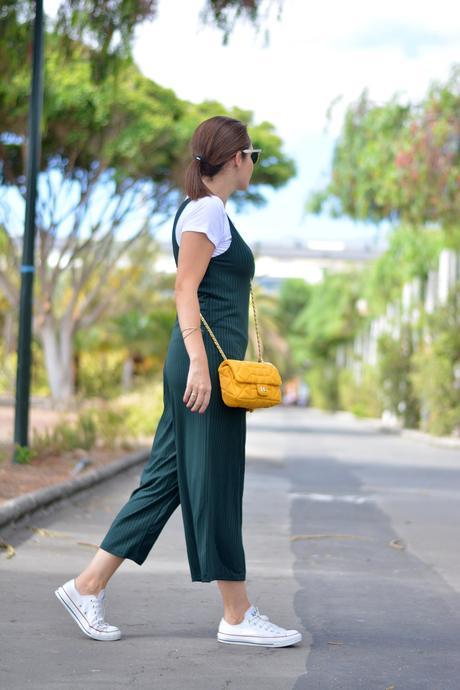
[176,196,227,247]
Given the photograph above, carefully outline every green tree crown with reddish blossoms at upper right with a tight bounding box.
[307,64,460,240]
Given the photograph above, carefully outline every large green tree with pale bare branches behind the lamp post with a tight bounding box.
[0,25,294,402]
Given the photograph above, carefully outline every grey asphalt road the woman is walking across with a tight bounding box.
[0,408,460,690]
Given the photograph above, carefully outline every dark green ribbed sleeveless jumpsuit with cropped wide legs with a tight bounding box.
[100,198,255,582]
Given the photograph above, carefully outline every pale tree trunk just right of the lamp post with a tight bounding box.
[39,318,75,408]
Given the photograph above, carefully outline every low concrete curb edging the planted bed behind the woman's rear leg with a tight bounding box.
[0,450,149,527]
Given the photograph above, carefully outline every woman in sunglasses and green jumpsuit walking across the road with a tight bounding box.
[55,116,302,647]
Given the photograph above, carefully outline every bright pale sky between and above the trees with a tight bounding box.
[45,0,460,246]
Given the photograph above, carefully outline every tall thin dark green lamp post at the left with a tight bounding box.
[13,0,44,462]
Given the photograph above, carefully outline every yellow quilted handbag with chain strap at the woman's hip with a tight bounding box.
[200,284,282,412]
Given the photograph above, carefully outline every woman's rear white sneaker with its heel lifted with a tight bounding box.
[54,578,121,640]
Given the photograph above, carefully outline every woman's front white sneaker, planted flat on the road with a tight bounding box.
[217,606,302,647]
